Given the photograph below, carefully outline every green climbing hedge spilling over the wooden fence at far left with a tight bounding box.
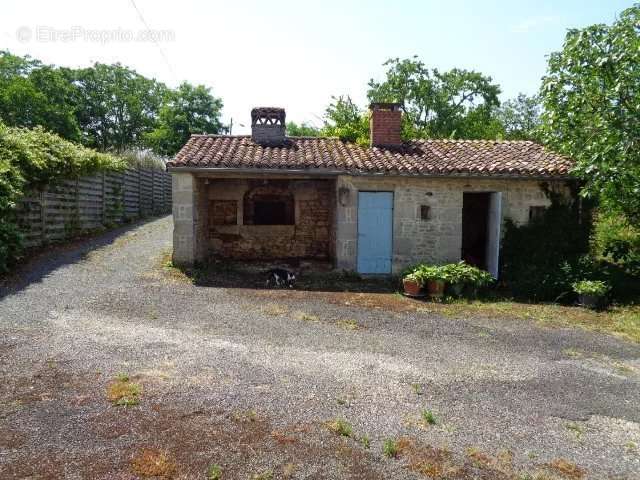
[0,123,125,272]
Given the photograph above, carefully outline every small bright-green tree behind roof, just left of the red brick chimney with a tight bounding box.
[321,95,369,145]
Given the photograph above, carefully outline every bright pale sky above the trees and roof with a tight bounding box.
[0,0,633,133]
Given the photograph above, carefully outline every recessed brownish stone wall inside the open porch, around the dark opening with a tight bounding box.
[206,178,335,259]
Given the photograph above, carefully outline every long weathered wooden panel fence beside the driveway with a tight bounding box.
[16,168,171,247]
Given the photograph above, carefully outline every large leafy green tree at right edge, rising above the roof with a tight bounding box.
[541,4,640,224]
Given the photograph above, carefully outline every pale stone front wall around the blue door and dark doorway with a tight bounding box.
[336,176,568,273]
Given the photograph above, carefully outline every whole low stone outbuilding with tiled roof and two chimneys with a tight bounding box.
[167,104,572,276]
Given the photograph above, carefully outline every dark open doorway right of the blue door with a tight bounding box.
[461,193,491,270]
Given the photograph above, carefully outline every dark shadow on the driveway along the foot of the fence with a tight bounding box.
[0,217,170,299]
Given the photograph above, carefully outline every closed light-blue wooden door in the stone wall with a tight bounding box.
[357,192,393,273]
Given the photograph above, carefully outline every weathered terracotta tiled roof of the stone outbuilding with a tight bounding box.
[167,135,572,177]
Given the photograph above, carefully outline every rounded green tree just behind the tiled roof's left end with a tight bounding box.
[145,82,222,155]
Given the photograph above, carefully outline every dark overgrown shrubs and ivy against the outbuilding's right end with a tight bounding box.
[502,185,640,303]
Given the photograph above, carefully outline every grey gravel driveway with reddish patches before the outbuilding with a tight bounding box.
[0,217,640,479]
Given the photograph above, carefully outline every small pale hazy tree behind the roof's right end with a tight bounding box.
[496,93,541,141]
